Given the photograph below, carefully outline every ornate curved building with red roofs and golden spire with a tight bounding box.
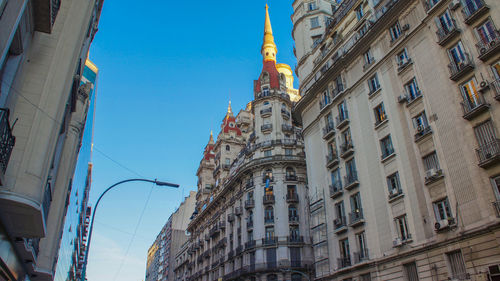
[180,5,312,281]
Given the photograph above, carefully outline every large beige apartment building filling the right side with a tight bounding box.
[292,0,500,281]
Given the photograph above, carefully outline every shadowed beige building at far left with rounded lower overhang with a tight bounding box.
[0,0,102,280]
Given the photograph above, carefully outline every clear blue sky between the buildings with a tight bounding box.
[88,0,296,281]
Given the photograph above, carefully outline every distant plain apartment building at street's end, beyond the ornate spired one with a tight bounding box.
[145,191,196,281]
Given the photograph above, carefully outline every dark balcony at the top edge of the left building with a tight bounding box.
[33,0,61,33]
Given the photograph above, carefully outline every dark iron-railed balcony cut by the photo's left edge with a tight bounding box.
[0,108,16,186]
